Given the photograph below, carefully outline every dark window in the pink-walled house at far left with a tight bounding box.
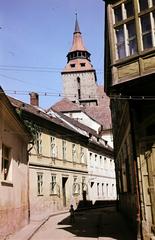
[2,144,11,180]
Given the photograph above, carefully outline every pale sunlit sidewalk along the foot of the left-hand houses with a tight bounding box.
[5,210,68,240]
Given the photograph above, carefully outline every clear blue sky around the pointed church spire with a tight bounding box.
[0,0,104,108]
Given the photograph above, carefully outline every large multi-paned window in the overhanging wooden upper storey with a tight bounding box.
[113,0,155,60]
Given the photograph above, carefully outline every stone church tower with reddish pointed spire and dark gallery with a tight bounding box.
[61,15,98,106]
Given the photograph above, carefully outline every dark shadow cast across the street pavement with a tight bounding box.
[58,207,136,240]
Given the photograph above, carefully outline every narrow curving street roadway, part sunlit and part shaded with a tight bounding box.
[31,208,136,240]
